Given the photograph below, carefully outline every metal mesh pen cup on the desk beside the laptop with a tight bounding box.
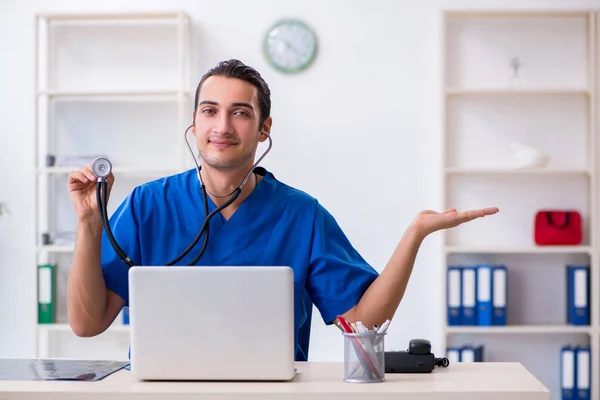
[342,332,386,383]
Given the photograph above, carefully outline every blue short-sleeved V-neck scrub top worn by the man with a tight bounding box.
[101,167,378,361]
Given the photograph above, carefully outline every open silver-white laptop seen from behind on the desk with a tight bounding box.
[129,266,295,381]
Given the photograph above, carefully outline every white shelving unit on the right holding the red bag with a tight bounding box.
[441,10,600,399]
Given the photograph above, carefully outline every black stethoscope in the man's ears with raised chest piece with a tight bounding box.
[92,124,273,267]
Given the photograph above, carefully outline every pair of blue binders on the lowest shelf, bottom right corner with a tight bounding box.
[560,345,591,400]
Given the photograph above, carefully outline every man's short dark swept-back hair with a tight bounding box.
[194,59,271,129]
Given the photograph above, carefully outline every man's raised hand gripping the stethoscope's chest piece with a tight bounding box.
[68,165,115,224]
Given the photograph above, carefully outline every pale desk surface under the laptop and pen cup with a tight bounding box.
[0,362,550,400]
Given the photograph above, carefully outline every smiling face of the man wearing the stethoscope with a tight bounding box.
[194,76,264,170]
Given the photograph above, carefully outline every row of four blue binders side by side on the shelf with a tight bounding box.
[446,264,507,326]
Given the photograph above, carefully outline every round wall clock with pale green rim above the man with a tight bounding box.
[263,19,317,73]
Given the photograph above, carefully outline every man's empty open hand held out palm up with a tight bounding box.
[413,207,499,236]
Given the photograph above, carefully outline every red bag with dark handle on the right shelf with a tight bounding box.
[534,210,582,246]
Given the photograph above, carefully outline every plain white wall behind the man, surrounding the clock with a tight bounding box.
[0,0,600,360]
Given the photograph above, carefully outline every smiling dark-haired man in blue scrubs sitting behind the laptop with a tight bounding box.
[68,60,498,360]
